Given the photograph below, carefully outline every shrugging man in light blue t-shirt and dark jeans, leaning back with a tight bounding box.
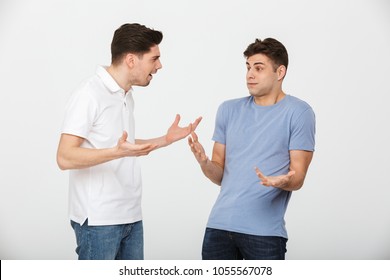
[188,38,315,260]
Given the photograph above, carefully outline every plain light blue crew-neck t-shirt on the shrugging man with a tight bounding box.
[207,95,315,238]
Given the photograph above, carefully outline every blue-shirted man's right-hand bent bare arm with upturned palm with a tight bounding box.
[255,150,313,191]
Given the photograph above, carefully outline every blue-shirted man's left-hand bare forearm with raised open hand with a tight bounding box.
[188,132,225,186]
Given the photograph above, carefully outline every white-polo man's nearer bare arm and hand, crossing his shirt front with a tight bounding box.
[57,132,156,170]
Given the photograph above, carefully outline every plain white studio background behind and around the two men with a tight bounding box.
[0,0,390,260]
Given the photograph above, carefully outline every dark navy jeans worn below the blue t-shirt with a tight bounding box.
[202,228,287,260]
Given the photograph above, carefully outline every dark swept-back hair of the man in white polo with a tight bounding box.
[111,23,163,64]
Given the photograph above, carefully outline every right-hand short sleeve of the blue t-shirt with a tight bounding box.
[289,107,316,151]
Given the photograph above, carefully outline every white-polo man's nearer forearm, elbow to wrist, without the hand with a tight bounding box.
[57,147,122,170]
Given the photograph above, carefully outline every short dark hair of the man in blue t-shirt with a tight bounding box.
[244,38,288,71]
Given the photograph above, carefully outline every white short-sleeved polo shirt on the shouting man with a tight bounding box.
[62,67,142,225]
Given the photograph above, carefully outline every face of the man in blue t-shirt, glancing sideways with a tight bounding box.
[246,54,279,97]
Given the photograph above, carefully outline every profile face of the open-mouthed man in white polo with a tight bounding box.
[132,45,162,86]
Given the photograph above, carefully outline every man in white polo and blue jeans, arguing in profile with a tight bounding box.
[57,24,201,259]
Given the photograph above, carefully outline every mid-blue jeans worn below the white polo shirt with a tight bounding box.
[71,220,144,260]
